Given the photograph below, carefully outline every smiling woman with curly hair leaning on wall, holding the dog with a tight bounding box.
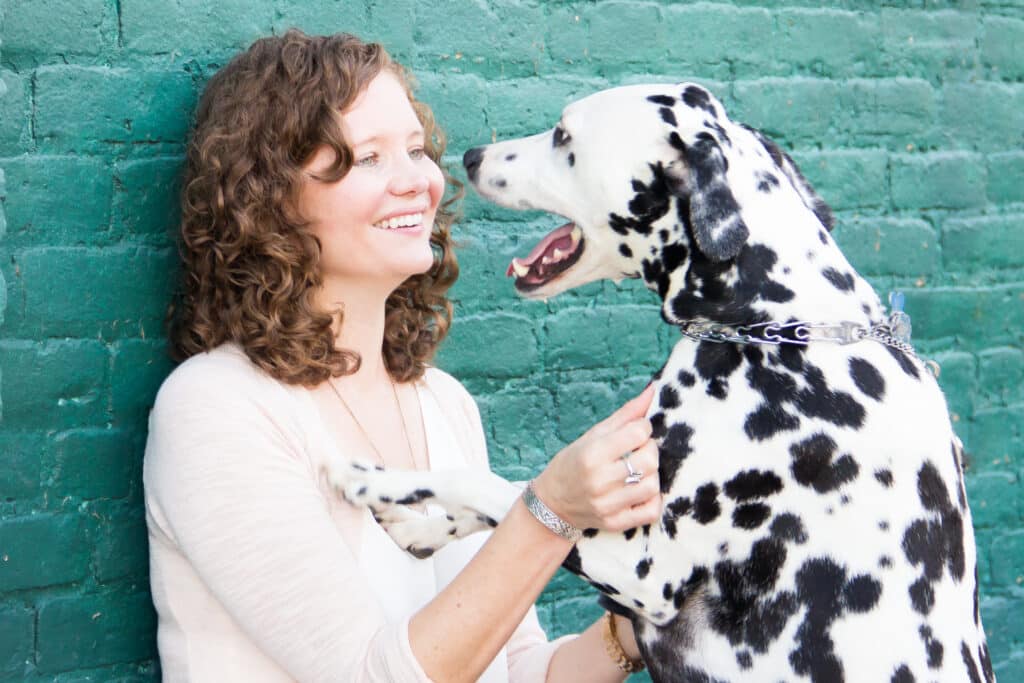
[144,31,659,682]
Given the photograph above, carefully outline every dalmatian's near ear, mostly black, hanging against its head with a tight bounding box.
[669,133,751,261]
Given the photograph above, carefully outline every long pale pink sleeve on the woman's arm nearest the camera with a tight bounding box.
[144,359,429,682]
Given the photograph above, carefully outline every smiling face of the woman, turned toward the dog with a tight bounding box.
[299,72,444,289]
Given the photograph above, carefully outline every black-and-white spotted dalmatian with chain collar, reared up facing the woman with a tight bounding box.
[335,83,994,683]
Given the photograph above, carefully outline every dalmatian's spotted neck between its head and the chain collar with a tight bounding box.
[642,198,885,326]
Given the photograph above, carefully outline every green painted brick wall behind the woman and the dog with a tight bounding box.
[0,0,1024,682]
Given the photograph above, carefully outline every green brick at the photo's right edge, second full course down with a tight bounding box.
[942,83,1024,152]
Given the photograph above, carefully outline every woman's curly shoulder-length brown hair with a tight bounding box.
[169,30,462,386]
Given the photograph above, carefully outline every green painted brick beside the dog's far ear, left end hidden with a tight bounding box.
[793,150,889,211]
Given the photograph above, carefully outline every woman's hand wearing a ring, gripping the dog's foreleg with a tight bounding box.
[534,385,662,531]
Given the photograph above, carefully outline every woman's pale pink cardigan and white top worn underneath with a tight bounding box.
[143,345,559,683]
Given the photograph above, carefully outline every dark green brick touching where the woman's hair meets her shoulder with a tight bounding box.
[111,338,174,429]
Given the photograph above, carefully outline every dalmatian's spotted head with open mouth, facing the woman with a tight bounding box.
[464,83,831,321]
